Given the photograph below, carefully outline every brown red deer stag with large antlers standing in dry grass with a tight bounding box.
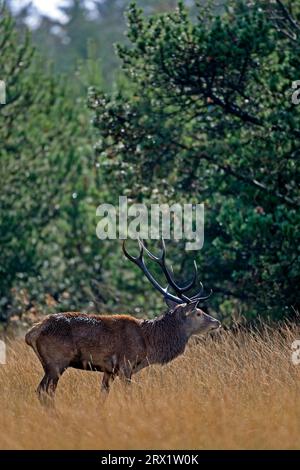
[25,240,220,399]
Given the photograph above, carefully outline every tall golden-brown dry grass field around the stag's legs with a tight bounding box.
[0,325,300,449]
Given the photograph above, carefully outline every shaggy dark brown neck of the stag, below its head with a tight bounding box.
[141,312,189,364]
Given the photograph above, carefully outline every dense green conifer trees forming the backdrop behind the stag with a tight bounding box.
[0,0,300,323]
